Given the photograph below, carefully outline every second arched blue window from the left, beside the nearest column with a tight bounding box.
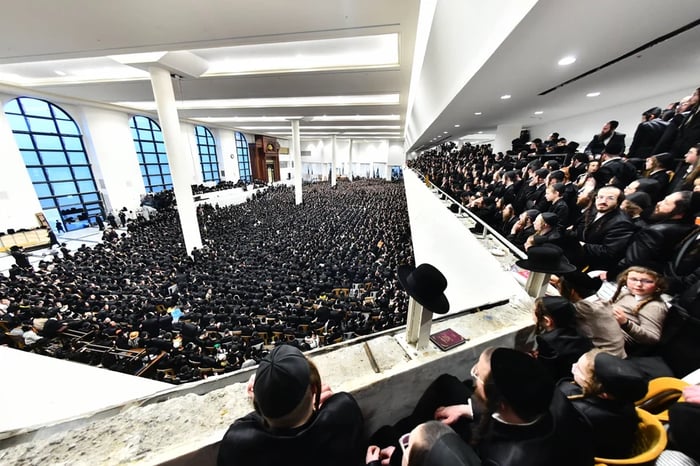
[129,115,173,193]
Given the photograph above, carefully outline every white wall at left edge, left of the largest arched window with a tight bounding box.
[0,95,41,231]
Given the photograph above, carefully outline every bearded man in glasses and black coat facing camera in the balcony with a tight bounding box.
[576,186,634,270]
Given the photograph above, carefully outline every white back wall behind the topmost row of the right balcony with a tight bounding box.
[528,89,693,151]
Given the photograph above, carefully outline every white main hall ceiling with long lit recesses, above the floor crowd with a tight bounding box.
[0,0,419,141]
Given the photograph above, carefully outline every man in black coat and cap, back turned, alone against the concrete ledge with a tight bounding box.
[217,345,365,466]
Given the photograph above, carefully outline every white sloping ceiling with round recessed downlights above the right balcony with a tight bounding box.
[407,0,700,150]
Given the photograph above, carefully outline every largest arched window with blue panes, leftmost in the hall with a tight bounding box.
[4,97,104,231]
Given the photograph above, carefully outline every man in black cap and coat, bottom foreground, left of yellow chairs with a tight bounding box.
[475,348,593,466]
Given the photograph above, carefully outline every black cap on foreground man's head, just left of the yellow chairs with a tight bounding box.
[491,348,554,421]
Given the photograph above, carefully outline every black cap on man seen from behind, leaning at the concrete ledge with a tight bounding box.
[253,345,310,419]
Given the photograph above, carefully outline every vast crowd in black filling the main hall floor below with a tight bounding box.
[0,180,413,383]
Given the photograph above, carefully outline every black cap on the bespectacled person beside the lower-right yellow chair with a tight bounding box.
[593,353,649,401]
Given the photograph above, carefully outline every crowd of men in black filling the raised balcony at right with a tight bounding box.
[408,113,700,293]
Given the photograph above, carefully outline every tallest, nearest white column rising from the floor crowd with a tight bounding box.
[148,67,202,254]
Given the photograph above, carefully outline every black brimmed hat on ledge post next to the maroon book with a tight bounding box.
[397,264,450,314]
